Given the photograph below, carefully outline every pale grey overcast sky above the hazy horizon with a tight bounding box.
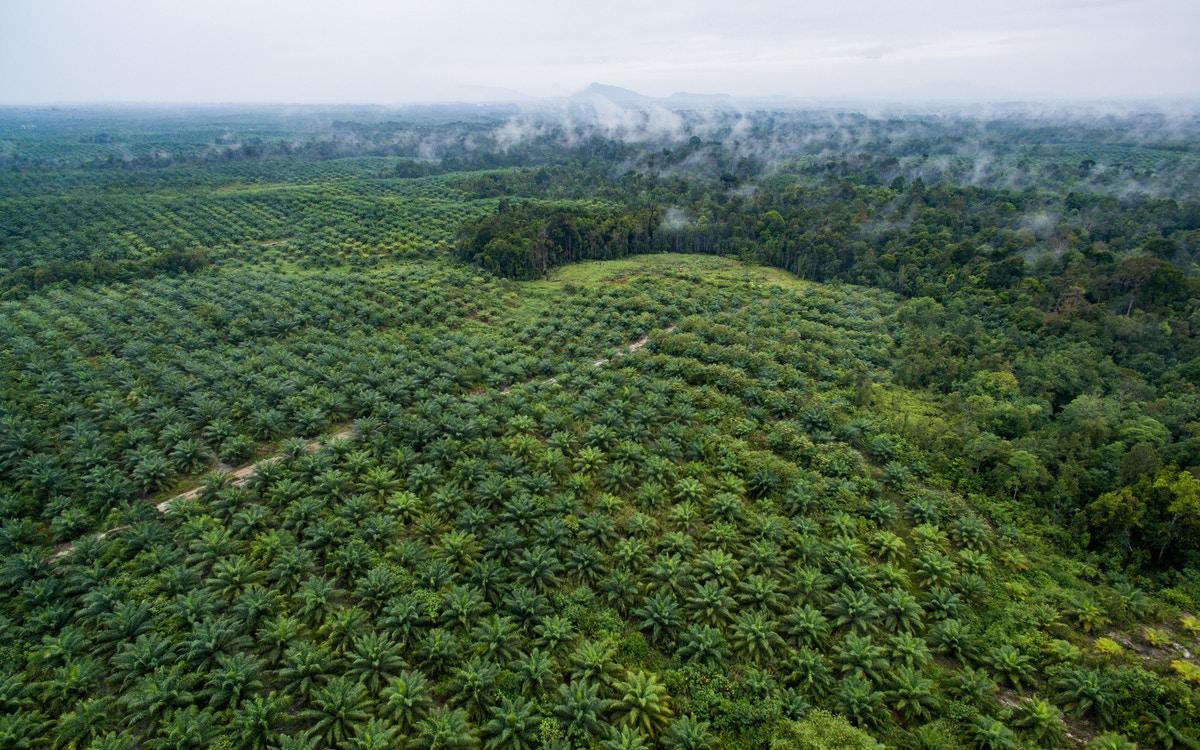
[0,0,1200,103]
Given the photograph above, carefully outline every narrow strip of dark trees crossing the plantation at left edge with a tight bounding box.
[0,250,212,299]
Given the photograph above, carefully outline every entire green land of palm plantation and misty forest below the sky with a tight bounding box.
[0,106,1200,750]
